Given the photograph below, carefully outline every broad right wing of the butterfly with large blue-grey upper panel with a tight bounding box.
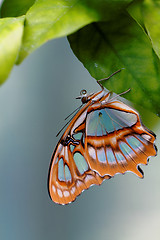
[85,97,156,177]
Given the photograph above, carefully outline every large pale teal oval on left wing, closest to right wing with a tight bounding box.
[73,152,88,174]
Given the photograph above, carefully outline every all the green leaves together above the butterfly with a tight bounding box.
[0,0,160,115]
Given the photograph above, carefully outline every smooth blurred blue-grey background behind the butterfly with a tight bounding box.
[0,38,160,240]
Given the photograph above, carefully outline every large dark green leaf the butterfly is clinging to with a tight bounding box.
[69,15,160,114]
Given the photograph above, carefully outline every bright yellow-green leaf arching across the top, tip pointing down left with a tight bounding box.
[18,0,132,63]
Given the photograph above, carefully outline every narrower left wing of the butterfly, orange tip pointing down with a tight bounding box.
[48,97,110,204]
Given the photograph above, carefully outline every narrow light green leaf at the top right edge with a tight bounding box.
[142,0,160,58]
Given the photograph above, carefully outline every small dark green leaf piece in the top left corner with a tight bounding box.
[1,0,35,17]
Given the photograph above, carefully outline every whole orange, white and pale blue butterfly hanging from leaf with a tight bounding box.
[48,70,156,205]
